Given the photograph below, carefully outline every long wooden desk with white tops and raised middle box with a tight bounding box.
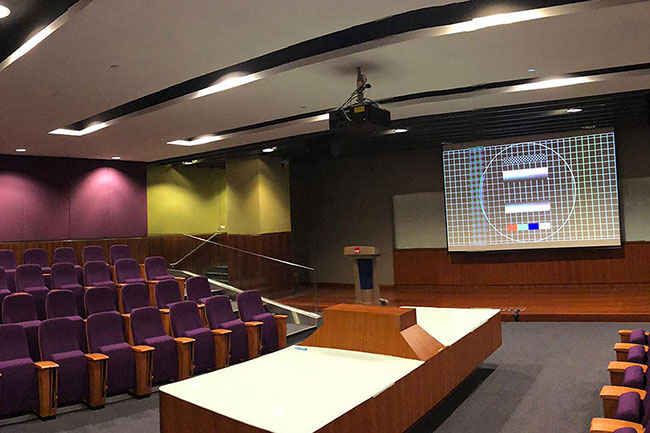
[160,304,501,433]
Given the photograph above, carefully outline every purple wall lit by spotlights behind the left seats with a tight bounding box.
[0,156,147,241]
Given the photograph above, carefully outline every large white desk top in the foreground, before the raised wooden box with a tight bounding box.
[160,346,423,433]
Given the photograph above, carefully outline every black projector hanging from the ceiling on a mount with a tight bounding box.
[329,67,390,134]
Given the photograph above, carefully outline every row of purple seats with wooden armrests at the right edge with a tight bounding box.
[590,329,650,433]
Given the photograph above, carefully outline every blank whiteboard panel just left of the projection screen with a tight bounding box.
[393,191,447,249]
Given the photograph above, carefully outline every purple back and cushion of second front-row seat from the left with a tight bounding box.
[38,318,89,405]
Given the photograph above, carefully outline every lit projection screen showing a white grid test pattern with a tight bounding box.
[443,132,620,250]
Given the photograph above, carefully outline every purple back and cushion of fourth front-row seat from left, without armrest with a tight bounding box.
[131,306,178,383]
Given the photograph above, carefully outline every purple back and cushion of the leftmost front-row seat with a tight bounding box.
[0,325,38,417]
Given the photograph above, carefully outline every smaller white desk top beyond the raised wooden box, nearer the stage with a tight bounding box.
[402,306,500,346]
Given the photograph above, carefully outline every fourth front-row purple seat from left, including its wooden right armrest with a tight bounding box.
[131,306,194,384]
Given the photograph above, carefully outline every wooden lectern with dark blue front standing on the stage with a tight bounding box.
[343,246,381,305]
